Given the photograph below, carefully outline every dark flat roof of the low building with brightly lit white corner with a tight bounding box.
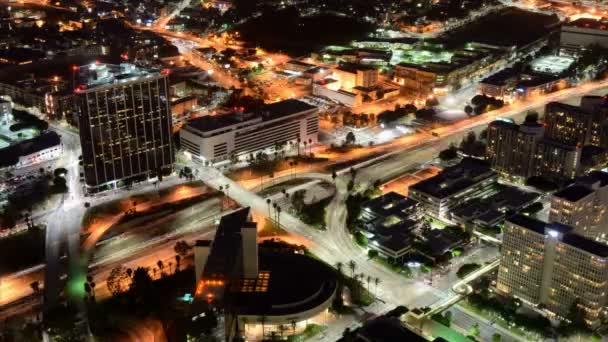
[410,158,494,198]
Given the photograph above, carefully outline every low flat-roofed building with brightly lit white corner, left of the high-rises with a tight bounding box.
[409,158,498,220]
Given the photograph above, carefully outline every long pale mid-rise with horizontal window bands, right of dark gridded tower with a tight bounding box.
[180,100,319,164]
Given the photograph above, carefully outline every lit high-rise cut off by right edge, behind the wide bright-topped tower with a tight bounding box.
[549,171,608,241]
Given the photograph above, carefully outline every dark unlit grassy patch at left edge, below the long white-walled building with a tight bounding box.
[0,228,45,275]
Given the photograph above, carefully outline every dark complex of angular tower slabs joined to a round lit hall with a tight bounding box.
[194,208,337,341]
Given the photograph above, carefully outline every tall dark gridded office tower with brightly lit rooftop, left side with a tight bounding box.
[75,64,174,192]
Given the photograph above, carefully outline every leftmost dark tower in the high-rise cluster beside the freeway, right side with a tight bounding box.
[486,120,543,179]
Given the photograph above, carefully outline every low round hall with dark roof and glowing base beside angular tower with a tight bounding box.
[227,252,337,337]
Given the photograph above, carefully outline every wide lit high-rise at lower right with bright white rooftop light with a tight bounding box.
[496,215,608,326]
